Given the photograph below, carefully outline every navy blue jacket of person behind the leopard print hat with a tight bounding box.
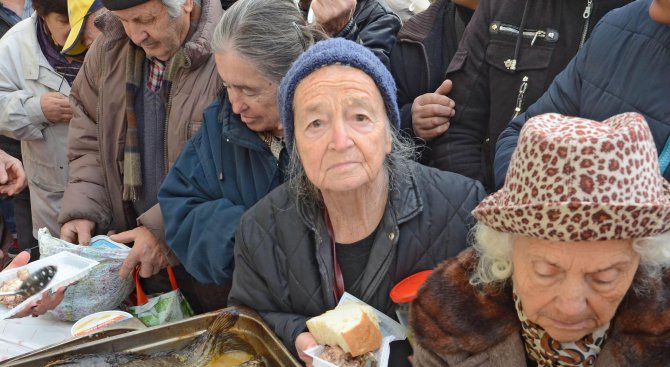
[494,0,670,187]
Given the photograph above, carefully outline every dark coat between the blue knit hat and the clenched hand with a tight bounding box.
[391,0,472,141]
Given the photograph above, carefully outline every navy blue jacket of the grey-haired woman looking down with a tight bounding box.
[158,93,288,284]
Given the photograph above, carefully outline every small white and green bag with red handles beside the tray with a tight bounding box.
[128,266,195,326]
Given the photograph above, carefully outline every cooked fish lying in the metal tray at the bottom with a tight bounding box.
[47,311,270,367]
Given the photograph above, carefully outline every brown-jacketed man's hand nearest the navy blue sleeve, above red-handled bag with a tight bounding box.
[109,226,168,278]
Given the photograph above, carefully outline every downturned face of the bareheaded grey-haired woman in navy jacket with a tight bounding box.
[214,51,284,136]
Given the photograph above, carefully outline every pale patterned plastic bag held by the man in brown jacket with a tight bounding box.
[37,228,134,321]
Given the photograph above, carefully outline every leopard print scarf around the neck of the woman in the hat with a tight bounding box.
[513,292,610,367]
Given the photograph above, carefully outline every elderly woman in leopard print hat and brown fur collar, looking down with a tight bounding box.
[410,113,670,367]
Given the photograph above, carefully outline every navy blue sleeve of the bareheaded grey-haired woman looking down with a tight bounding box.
[158,134,245,284]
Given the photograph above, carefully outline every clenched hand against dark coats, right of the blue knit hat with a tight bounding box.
[412,79,456,140]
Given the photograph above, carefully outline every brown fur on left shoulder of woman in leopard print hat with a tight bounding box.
[410,249,520,354]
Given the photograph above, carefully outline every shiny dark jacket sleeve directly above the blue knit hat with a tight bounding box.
[335,0,401,68]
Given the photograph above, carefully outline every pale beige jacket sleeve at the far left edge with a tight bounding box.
[0,37,51,140]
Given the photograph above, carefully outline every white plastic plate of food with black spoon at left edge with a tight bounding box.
[0,251,98,320]
